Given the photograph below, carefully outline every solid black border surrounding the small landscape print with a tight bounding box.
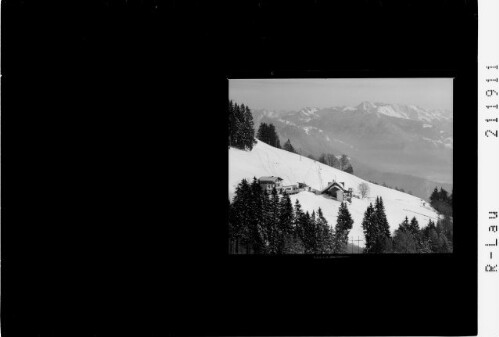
[1,0,477,336]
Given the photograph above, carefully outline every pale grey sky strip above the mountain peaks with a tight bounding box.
[229,78,453,111]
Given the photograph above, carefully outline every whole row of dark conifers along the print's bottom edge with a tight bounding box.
[228,178,453,254]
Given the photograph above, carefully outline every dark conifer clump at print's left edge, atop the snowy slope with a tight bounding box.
[227,101,256,150]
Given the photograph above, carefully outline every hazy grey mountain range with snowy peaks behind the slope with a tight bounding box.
[252,101,453,198]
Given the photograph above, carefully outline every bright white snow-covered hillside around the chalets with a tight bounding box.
[229,141,438,246]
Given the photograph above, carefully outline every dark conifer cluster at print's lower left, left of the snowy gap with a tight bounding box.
[228,178,353,254]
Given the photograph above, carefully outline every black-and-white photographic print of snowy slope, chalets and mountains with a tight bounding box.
[228,78,453,254]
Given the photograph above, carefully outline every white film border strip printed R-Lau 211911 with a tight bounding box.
[478,0,499,337]
